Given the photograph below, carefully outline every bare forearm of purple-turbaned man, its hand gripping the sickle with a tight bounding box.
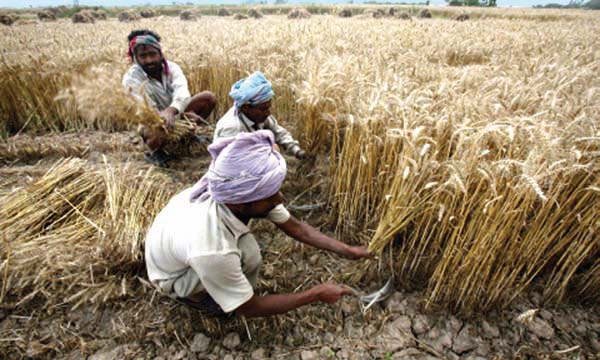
[236,283,352,317]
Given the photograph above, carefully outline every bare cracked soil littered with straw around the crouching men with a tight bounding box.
[0,132,600,360]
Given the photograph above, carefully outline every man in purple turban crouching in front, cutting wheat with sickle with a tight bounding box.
[145,130,369,317]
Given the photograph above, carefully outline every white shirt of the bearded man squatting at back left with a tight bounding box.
[123,61,190,114]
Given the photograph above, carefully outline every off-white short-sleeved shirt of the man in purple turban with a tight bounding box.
[145,188,290,312]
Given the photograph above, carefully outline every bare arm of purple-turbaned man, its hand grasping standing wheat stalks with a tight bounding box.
[275,216,370,259]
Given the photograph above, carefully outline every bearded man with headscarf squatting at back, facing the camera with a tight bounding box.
[123,30,217,165]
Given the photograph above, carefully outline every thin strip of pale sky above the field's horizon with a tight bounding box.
[0,0,569,8]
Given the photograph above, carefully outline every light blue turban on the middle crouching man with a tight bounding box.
[229,71,275,109]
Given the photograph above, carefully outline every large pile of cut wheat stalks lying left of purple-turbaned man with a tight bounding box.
[0,159,173,307]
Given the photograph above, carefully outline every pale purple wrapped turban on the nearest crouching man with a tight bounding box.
[190,130,287,204]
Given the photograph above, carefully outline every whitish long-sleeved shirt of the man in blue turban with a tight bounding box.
[213,106,300,155]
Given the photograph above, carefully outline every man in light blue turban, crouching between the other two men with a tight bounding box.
[213,71,306,159]
